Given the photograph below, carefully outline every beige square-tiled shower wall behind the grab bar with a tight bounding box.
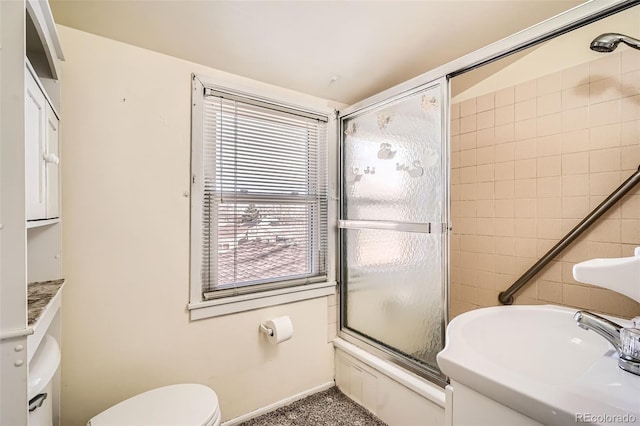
[451,50,640,317]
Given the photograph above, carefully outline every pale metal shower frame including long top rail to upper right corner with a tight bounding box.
[337,0,640,387]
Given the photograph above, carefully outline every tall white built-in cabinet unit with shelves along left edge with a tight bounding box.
[0,0,64,426]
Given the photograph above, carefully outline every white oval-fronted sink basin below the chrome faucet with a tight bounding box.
[437,305,640,425]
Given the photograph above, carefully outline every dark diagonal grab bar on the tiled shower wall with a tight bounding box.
[498,166,640,305]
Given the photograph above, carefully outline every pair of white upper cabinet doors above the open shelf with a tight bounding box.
[25,68,60,221]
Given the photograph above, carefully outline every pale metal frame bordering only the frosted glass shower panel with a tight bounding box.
[337,76,451,387]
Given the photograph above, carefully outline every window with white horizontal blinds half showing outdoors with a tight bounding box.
[191,77,328,300]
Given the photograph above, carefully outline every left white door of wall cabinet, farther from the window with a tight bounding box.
[25,70,47,220]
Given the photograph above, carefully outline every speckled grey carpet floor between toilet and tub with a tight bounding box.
[240,386,386,426]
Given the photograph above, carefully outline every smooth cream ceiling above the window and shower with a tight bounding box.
[50,0,583,104]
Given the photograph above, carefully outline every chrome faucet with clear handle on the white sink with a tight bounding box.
[573,311,640,376]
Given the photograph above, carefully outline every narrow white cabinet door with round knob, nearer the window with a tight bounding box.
[44,103,60,219]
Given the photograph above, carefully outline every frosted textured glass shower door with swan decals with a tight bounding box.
[340,84,446,371]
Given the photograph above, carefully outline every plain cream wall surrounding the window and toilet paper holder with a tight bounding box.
[59,27,336,426]
